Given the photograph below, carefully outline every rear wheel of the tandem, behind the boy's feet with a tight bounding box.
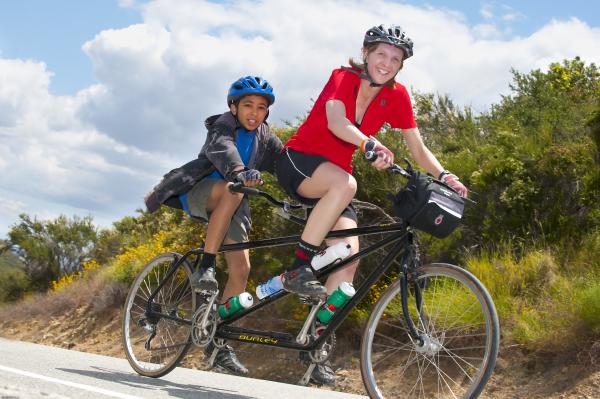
[122,252,196,378]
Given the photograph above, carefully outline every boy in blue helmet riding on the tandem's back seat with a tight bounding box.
[146,76,283,375]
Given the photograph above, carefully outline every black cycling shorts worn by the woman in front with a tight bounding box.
[275,148,358,222]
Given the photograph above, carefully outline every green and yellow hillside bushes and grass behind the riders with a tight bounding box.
[0,58,600,352]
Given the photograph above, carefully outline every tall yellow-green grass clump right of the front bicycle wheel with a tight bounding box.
[466,245,600,350]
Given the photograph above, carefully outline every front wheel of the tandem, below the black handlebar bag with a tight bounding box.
[361,263,500,399]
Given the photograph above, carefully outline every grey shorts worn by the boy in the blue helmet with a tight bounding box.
[185,179,248,242]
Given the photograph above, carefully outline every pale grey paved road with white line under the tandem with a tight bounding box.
[0,338,365,399]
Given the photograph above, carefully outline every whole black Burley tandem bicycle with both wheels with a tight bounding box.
[122,165,500,398]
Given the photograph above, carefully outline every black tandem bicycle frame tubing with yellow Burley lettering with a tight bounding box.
[146,223,420,351]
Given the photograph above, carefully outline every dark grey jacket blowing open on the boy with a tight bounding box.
[144,112,283,228]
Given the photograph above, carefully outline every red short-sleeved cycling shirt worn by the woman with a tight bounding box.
[285,68,417,173]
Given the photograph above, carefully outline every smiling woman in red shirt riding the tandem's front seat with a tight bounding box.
[276,25,467,384]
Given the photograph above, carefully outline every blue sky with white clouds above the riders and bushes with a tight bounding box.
[0,0,600,238]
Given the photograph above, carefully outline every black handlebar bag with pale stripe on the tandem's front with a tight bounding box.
[393,170,465,238]
